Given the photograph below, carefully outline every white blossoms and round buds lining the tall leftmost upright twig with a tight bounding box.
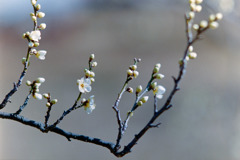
[23,0,47,63]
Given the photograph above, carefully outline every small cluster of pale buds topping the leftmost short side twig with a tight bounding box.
[26,77,45,100]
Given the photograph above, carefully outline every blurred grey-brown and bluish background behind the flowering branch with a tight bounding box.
[0,0,240,160]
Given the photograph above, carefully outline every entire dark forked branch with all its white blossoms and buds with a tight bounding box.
[0,0,222,157]
